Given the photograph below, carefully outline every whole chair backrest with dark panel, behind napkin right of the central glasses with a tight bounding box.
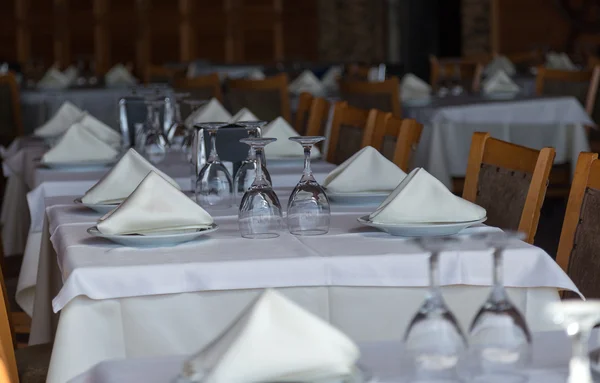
[327,101,379,164]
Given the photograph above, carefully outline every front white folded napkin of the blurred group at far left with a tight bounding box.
[42,126,119,163]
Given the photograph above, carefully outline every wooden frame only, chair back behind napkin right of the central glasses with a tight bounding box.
[327,101,381,163]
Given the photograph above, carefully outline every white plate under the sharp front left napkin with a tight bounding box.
[87,223,219,247]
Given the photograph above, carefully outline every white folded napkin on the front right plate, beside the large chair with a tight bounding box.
[369,168,486,224]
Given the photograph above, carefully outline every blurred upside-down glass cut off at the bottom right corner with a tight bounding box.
[548,299,600,383]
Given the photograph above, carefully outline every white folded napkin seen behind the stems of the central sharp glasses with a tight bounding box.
[262,117,321,159]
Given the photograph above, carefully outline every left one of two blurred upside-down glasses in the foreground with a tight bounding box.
[404,237,466,382]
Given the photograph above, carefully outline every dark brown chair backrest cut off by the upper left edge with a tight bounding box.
[0,72,23,145]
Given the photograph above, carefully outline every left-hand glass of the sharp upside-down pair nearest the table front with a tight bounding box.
[238,138,282,239]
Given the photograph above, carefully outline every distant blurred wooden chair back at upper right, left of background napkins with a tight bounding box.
[429,56,484,92]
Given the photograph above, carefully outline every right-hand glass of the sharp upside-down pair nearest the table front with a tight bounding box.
[287,136,331,235]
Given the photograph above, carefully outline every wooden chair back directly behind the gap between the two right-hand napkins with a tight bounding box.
[371,112,423,173]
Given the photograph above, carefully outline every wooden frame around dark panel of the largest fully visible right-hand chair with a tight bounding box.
[463,132,555,243]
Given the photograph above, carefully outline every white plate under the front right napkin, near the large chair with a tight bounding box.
[358,215,487,237]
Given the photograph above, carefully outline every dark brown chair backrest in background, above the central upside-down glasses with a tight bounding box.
[226,73,291,121]
